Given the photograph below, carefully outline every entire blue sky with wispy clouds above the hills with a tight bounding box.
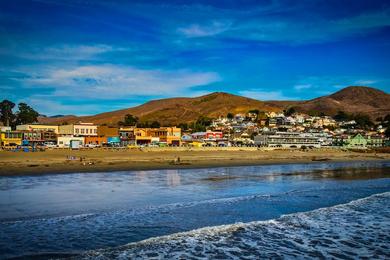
[0,0,390,116]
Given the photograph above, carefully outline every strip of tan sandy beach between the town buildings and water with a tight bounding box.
[0,147,390,176]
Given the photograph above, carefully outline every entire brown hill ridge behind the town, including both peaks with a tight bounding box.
[39,86,390,125]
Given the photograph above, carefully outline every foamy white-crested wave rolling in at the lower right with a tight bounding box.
[75,192,390,259]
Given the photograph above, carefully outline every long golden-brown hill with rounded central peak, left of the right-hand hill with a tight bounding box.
[38,92,282,125]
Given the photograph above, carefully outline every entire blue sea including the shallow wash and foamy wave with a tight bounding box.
[0,162,390,259]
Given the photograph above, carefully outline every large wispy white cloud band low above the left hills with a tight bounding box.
[21,64,220,100]
